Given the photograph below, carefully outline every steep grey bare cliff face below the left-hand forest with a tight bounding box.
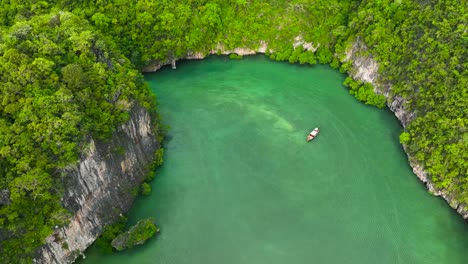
[34,106,159,264]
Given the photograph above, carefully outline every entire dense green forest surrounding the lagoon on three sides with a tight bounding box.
[0,0,468,261]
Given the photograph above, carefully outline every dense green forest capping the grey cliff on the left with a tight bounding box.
[0,10,152,262]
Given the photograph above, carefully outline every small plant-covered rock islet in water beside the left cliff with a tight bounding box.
[112,218,159,251]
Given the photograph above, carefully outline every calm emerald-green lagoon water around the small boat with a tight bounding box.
[81,56,468,264]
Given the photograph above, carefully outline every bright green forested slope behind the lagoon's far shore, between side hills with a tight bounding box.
[44,0,354,69]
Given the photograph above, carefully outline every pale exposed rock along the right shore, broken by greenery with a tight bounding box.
[344,40,468,219]
